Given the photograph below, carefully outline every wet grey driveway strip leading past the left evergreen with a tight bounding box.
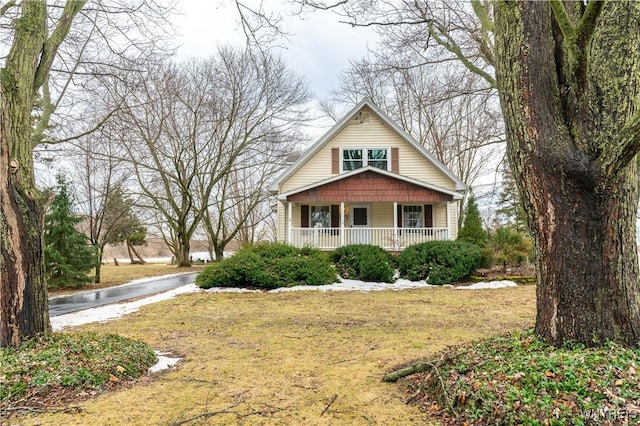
[49,273,197,317]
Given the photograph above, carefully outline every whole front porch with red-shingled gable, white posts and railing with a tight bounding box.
[278,168,462,252]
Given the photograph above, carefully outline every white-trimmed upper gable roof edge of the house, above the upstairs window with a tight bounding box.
[269,99,467,193]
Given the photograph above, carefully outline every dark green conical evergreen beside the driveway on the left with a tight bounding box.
[44,175,95,288]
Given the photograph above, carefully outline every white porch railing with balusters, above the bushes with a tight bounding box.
[289,228,449,251]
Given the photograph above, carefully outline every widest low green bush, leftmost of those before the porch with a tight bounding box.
[196,243,336,289]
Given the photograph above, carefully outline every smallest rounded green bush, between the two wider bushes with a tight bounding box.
[330,244,396,283]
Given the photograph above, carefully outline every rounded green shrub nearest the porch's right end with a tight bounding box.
[398,241,482,285]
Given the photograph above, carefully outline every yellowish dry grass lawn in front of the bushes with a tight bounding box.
[17,286,535,425]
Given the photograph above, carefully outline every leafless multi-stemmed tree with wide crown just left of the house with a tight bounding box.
[110,48,307,266]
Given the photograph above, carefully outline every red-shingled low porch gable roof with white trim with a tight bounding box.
[278,166,462,203]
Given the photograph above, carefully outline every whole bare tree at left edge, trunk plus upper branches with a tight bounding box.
[0,0,175,346]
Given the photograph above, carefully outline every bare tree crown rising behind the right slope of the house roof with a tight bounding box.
[333,57,504,223]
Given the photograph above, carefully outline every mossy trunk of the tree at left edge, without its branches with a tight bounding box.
[0,1,51,346]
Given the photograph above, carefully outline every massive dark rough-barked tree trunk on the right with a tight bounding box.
[496,1,640,346]
